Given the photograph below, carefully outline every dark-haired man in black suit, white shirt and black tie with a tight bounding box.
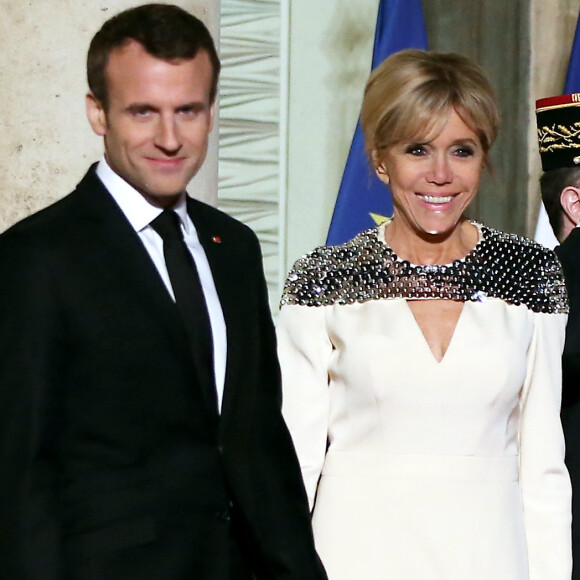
[0,4,325,580]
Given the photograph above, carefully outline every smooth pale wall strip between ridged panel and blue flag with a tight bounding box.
[286,0,378,268]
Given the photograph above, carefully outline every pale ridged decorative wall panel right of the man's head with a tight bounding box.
[218,0,287,312]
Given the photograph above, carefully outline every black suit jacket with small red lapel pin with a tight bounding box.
[0,167,324,580]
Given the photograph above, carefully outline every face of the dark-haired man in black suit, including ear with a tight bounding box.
[87,41,214,207]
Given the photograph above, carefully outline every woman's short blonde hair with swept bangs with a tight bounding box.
[361,49,499,165]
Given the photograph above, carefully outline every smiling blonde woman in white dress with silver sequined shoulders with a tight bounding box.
[278,50,571,580]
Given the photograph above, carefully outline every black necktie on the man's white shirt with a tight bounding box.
[150,209,217,410]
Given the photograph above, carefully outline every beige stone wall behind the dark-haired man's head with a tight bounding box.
[0,0,219,231]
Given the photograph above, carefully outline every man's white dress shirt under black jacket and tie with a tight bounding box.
[97,158,227,409]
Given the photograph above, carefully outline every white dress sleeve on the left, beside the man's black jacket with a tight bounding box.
[277,305,332,509]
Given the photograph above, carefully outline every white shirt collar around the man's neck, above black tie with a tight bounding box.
[97,157,189,233]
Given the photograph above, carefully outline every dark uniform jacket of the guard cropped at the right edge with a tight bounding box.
[556,228,580,580]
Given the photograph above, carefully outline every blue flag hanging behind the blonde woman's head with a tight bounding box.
[326,0,427,245]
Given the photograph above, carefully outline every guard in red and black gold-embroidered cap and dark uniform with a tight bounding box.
[536,94,580,580]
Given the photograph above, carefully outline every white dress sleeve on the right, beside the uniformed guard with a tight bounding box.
[519,313,572,580]
